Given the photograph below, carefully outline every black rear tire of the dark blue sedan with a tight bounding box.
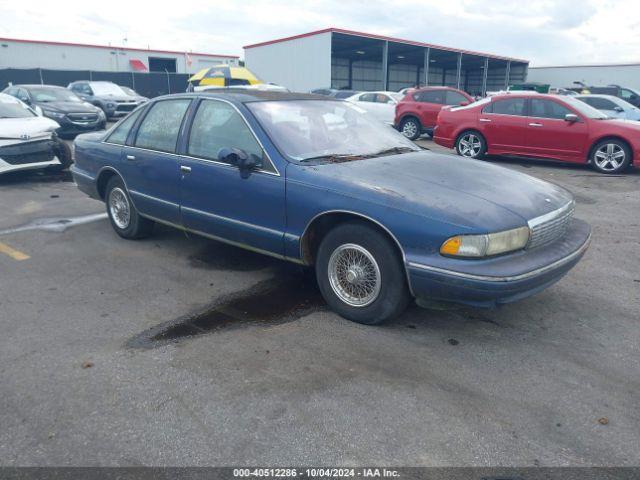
[104,176,155,239]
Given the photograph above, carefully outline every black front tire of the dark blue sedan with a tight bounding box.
[316,221,411,325]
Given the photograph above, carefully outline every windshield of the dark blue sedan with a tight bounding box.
[247,100,420,162]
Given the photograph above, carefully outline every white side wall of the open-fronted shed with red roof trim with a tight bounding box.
[244,32,331,92]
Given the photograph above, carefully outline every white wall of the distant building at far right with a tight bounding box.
[527,64,640,89]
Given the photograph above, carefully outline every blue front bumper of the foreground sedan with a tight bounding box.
[407,219,591,307]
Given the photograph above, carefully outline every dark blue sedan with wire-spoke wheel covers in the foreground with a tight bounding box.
[72,90,590,324]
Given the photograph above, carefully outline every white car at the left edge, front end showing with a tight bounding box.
[0,93,71,174]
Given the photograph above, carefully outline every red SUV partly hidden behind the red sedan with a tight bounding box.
[394,87,473,140]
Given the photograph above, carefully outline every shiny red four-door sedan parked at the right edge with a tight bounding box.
[433,93,640,173]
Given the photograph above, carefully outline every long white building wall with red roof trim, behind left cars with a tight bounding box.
[0,40,238,73]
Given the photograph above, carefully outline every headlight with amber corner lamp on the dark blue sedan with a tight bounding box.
[440,227,529,257]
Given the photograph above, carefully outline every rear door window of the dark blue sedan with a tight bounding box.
[135,98,191,153]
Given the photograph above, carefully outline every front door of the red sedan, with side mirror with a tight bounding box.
[527,98,589,162]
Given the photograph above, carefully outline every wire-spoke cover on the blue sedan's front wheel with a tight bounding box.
[328,243,382,307]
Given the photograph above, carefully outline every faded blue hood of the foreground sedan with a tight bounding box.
[287,152,573,231]
